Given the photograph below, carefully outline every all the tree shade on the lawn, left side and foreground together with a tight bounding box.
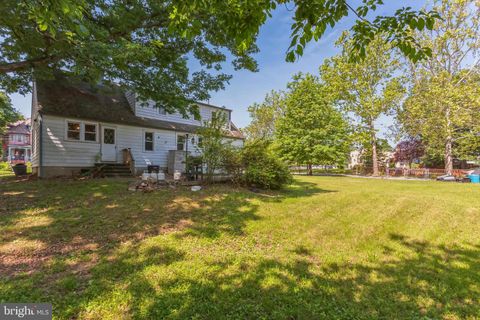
[0,180,480,319]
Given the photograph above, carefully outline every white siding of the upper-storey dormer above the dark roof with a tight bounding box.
[136,101,229,126]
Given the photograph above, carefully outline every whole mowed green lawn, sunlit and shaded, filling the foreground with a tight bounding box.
[0,177,480,319]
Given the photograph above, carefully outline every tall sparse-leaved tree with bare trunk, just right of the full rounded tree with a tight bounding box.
[320,35,404,176]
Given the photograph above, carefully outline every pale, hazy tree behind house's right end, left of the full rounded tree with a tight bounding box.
[244,90,285,140]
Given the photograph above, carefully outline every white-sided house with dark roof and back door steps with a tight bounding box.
[32,78,244,177]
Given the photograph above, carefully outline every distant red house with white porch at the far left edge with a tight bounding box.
[2,119,32,164]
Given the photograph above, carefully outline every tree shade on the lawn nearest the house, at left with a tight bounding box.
[0,179,327,277]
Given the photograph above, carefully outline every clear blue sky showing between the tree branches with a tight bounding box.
[11,0,425,140]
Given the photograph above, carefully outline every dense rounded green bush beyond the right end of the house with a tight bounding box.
[242,141,292,189]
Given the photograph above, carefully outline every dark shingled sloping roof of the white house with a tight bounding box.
[35,78,243,139]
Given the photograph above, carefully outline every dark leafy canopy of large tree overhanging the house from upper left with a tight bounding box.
[0,0,437,113]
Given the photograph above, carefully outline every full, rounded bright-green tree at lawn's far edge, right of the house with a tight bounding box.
[275,74,350,175]
